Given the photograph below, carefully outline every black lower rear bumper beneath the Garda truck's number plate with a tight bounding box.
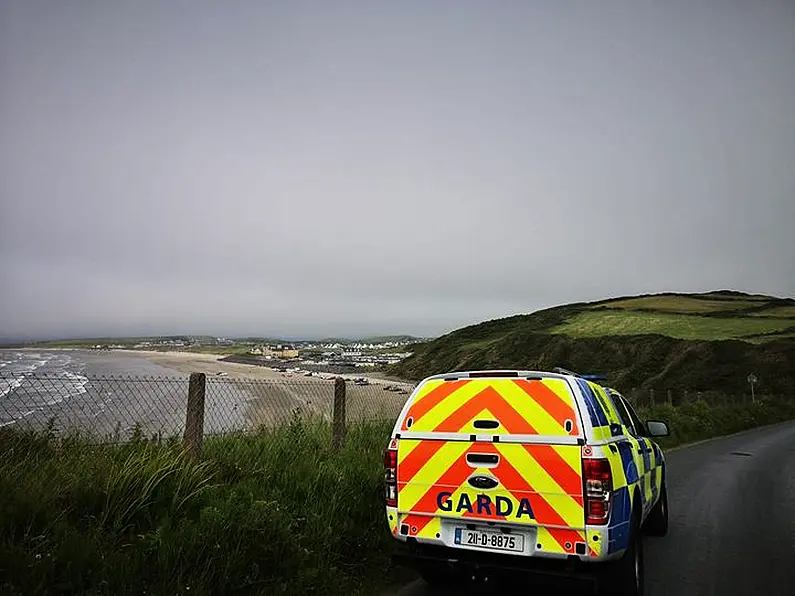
[392,541,601,585]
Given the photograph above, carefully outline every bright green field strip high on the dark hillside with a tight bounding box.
[549,310,786,340]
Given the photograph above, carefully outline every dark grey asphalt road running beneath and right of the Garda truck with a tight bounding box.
[393,423,795,596]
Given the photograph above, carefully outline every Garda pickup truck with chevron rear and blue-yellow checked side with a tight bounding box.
[384,369,668,596]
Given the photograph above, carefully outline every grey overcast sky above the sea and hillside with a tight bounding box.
[0,0,795,338]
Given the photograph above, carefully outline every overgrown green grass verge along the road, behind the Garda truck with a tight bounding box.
[0,402,795,595]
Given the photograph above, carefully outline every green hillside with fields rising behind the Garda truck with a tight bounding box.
[390,290,795,396]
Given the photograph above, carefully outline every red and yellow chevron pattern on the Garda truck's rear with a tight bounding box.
[393,379,593,554]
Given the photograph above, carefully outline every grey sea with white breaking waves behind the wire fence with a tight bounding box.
[0,349,252,440]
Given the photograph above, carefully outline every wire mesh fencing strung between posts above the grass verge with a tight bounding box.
[0,373,413,442]
